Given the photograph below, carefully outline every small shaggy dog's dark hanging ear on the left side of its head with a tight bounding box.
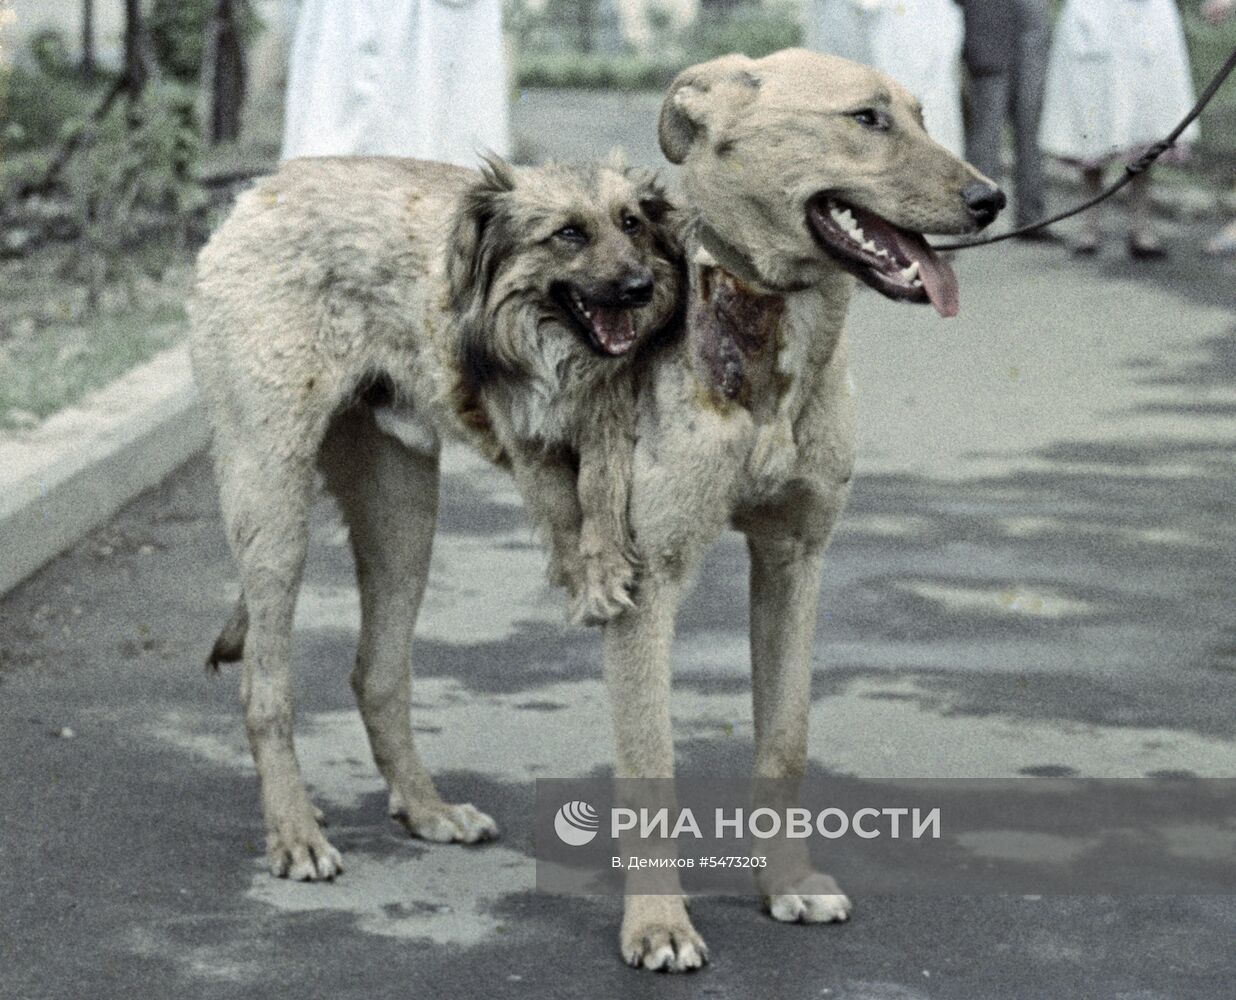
[446,153,515,384]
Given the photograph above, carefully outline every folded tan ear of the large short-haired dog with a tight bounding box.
[656,54,760,163]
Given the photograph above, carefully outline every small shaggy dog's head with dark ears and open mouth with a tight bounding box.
[447,157,681,382]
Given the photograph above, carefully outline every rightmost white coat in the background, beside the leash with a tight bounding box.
[1038,0,1198,166]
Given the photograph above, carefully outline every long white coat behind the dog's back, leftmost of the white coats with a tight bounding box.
[282,0,510,166]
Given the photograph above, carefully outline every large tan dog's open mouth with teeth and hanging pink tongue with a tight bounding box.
[807,195,958,316]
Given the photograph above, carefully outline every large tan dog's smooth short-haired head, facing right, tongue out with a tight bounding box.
[660,49,1005,315]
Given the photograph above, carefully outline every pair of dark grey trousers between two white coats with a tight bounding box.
[965,0,1052,225]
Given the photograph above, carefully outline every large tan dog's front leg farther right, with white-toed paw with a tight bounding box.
[748,536,850,923]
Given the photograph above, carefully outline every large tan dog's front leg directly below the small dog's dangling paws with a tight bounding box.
[604,578,708,972]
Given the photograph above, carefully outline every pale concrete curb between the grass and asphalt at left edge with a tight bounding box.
[0,345,209,593]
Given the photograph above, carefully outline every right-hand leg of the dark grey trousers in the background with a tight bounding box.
[1009,0,1051,226]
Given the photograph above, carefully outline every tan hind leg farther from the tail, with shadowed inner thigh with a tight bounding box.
[320,409,498,843]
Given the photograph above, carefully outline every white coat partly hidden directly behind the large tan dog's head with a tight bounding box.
[805,0,965,156]
